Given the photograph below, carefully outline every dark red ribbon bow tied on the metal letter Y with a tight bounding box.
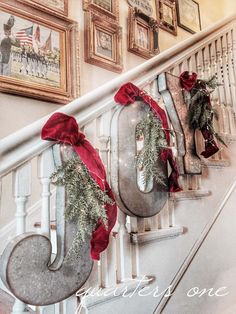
[179,71,219,158]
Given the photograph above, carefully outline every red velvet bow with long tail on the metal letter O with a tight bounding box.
[114,82,182,192]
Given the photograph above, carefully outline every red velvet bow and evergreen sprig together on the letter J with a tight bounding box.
[41,112,117,260]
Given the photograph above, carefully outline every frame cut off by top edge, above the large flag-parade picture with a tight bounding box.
[17,0,68,16]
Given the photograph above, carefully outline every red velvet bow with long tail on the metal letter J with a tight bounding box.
[41,112,117,260]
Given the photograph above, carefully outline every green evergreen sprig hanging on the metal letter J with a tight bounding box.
[51,157,114,257]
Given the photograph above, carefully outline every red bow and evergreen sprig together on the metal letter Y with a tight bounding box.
[180,71,226,158]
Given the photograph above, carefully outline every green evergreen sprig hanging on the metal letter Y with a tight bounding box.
[187,76,227,147]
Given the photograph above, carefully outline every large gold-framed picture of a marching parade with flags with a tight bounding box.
[0,0,79,103]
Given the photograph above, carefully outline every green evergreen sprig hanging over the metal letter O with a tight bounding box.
[135,110,167,187]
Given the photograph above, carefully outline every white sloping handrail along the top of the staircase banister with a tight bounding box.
[0,15,236,175]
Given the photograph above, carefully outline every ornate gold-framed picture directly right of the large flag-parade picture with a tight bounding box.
[84,12,122,73]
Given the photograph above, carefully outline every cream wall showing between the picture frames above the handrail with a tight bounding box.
[0,0,236,138]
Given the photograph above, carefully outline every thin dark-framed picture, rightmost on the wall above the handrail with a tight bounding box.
[176,0,201,34]
